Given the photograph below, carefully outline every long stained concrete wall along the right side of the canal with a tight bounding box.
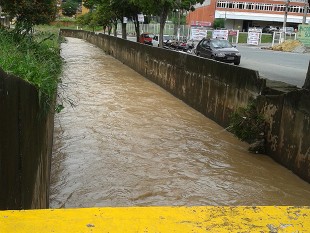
[61,30,310,182]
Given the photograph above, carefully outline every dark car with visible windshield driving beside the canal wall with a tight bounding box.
[195,38,241,65]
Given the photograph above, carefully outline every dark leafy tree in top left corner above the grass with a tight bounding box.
[0,0,56,35]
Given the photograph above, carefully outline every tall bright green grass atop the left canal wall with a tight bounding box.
[0,28,62,110]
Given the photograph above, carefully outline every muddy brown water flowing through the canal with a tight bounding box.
[50,38,310,208]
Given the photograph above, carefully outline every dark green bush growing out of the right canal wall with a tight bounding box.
[228,101,265,143]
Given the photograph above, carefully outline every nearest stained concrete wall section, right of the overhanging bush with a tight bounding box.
[258,89,310,182]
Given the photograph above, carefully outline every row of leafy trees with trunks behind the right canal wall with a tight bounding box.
[84,0,204,46]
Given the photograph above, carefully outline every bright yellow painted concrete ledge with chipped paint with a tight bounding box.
[0,206,310,233]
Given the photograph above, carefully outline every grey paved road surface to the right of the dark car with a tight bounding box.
[237,45,310,87]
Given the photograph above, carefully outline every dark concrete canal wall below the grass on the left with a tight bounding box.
[0,69,54,210]
